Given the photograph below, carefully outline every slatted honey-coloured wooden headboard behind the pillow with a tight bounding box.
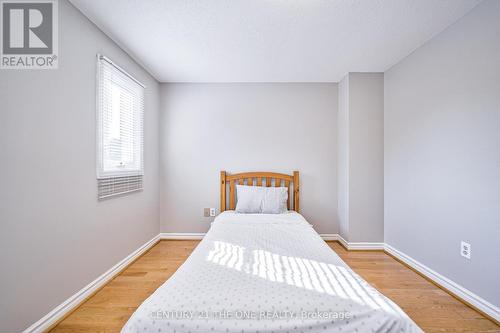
[220,171,300,213]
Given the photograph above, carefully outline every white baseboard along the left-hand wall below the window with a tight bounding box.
[23,235,160,333]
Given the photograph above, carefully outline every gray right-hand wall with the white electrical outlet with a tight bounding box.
[385,1,500,306]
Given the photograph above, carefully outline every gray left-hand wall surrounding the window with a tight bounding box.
[0,1,159,332]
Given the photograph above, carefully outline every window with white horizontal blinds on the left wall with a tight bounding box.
[97,55,144,199]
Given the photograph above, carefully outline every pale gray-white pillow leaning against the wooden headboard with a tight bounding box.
[236,185,288,214]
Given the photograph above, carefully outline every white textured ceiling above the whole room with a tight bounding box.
[71,0,480,82]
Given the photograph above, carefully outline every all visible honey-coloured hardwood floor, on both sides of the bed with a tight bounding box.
[51,240,500,333]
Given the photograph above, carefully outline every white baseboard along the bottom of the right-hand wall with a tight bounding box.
[385,243,500,321]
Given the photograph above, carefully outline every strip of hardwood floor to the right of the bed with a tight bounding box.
[328,242,500,333]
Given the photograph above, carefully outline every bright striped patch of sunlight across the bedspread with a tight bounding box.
[207,241,397,313]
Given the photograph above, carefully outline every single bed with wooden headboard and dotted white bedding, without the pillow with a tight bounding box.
[122,172,422,333]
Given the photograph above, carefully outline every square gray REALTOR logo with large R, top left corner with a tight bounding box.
[0,0,58,69]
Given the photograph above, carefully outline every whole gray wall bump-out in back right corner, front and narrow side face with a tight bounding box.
[338,73,384,242]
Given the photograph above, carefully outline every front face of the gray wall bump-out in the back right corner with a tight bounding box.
[349,73,384,242]
